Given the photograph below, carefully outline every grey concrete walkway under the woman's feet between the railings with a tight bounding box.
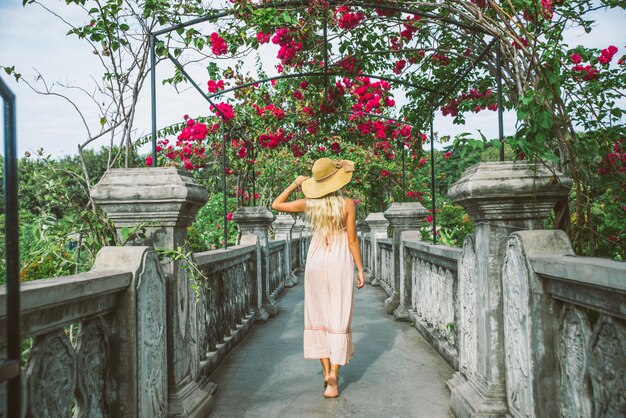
[211,279,453,418]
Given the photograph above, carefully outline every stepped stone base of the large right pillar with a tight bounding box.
[446,372,508,418]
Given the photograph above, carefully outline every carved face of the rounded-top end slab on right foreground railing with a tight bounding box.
[503,238,534,417]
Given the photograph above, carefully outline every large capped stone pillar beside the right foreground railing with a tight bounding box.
[448,161,571,417]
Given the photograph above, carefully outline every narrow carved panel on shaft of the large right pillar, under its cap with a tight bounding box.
[459,236,478,377]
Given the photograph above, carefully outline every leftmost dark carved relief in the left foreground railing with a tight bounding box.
[26,329,76,418]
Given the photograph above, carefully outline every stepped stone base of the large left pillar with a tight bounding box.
[167,376,217,418]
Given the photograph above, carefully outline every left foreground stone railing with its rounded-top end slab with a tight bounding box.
[0,247,168,417]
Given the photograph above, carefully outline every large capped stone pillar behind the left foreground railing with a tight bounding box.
[91,167,216,417]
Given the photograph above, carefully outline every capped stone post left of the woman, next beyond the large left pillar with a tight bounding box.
[233,206,278,316]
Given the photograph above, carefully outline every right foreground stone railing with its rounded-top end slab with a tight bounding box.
[503,231,626,417]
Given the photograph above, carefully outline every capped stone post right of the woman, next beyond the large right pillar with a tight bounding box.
[383,202,428,320]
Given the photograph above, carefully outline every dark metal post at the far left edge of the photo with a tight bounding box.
[0,79,22,417]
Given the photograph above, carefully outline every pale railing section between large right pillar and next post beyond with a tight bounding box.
[401,240,461,369]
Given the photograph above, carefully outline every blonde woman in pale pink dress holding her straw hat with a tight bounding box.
[272,158,365,398]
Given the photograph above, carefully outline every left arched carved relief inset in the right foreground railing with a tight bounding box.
[557,305,591,418]
